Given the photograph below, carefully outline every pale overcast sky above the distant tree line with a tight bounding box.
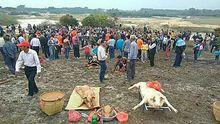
[0,0,220,10]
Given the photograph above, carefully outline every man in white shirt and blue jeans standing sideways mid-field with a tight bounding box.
[98,39,107,83]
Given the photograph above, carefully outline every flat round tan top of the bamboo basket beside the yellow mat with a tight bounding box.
[40,92,65,102]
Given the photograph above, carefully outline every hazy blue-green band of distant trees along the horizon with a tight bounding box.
[0,5,220,17]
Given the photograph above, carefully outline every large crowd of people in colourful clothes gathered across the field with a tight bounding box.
[0,25,219,94]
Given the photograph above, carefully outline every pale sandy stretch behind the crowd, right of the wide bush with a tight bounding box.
[119,17,220,32]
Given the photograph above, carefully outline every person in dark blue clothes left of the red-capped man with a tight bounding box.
[3,34,17,75]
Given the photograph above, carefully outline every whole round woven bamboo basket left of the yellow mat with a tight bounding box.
[39,92,65,115]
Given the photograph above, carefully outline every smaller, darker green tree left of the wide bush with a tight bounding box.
[60,14,79,26]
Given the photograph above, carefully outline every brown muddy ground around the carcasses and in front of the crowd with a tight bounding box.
[0,42,220,124]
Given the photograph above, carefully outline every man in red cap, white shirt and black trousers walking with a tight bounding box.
[15,41,41,96]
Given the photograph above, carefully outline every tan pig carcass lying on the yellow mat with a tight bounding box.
[75,85,96,108]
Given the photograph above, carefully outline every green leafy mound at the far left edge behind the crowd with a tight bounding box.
[0,12,17,26]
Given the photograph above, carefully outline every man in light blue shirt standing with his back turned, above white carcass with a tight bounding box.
[127,35,138,81]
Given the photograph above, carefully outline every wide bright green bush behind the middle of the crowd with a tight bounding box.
[82,14,115,27]
